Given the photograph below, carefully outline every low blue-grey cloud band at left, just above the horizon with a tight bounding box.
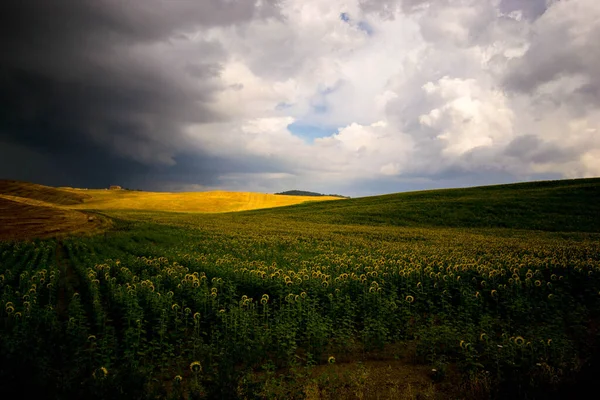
[0,134,280,191]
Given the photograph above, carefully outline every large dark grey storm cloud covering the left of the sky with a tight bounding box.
[0,0,277,185]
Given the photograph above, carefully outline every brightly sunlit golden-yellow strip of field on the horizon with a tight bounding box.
[62,189,339,213]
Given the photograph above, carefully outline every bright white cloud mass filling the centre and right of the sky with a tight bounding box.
[103,0,600,194]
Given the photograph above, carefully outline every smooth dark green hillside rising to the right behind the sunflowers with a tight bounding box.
[243,178,600,232]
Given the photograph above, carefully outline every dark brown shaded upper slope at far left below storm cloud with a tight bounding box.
[0,180,89,205]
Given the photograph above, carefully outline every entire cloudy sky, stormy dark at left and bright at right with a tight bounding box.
[0,0,600,197]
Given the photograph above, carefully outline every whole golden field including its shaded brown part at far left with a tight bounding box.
[0,180,339,240]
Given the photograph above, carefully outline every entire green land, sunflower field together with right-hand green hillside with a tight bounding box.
[0,179,600,399]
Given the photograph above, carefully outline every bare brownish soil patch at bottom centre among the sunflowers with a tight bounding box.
[241,342,466,400]
